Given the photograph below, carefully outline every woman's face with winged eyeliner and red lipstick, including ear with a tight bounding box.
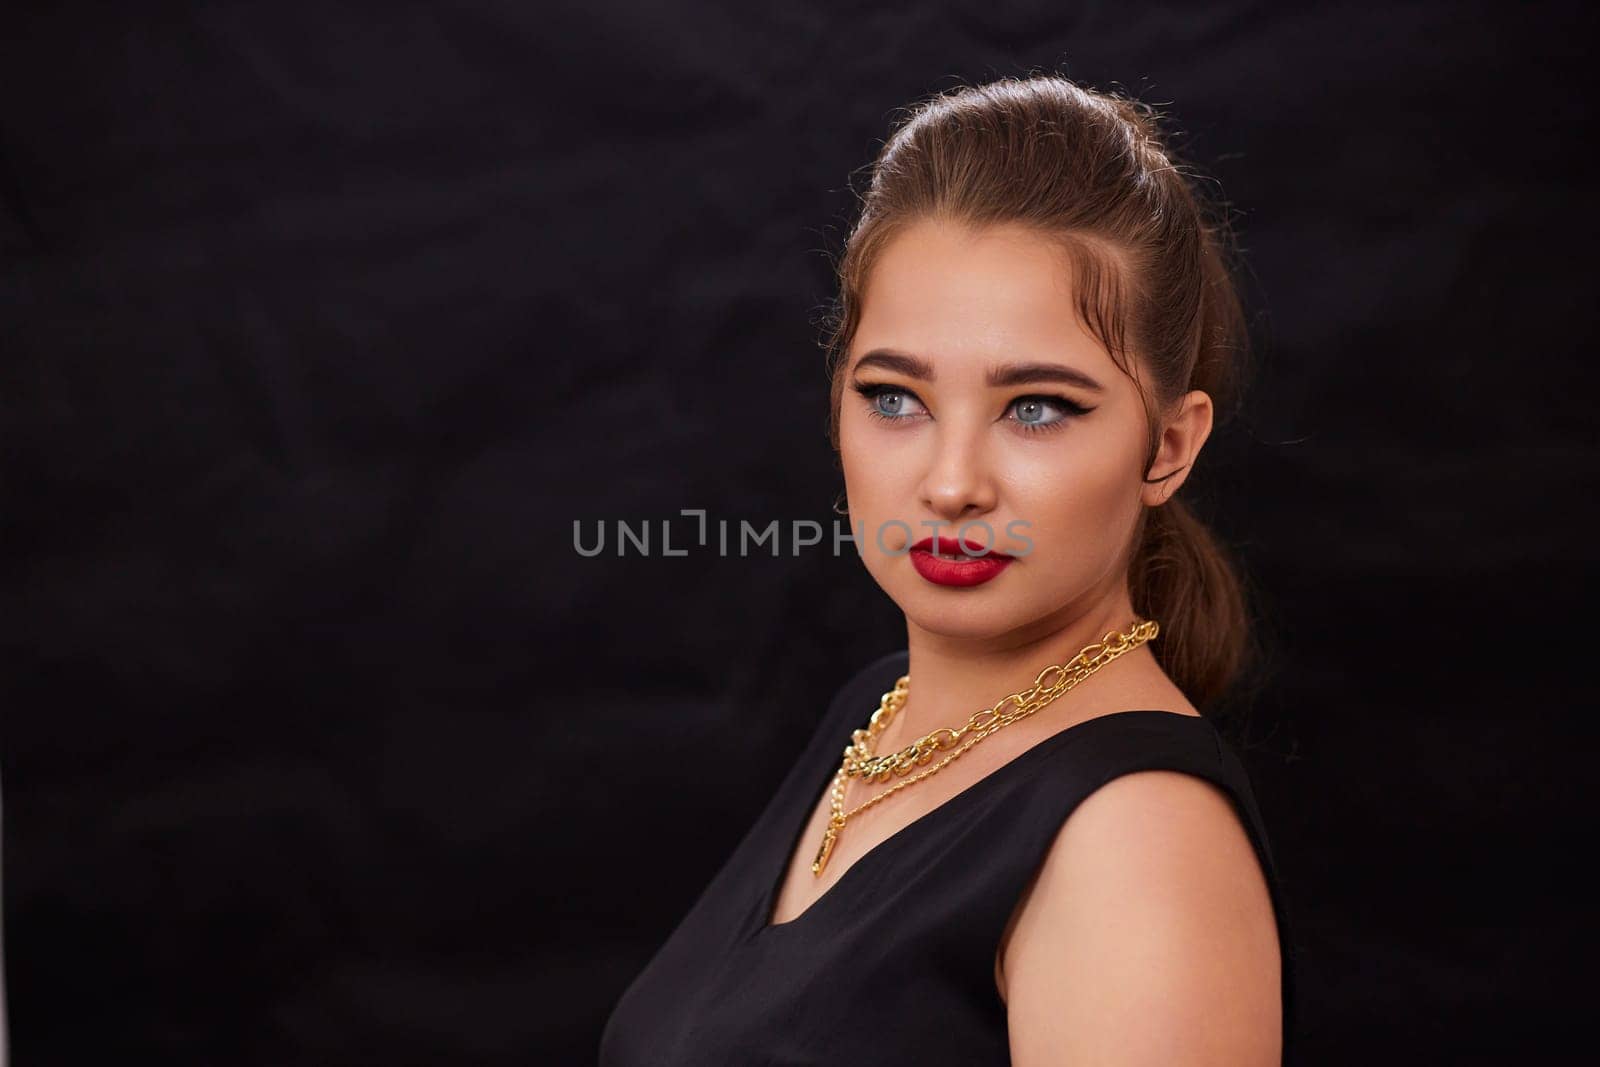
[838,212,1211,638]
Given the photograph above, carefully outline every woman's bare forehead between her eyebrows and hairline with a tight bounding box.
[850,221,1115,381]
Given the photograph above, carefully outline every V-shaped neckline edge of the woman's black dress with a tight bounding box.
[746,709,1210,941]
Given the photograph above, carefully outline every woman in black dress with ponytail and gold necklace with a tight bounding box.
[600,77,1291,1067]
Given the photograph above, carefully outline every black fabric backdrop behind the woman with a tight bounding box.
[0,2,1597,1067]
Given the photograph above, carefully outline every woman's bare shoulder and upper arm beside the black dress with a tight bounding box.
[1003,771,1282,1067]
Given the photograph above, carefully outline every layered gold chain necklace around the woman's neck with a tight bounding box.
[811,619,1162,875]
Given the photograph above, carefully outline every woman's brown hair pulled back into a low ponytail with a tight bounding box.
[826,74,1253,707]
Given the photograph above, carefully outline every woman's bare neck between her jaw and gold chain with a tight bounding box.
[878,590,1160,752]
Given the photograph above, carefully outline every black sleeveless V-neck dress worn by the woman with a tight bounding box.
[600,651,1293,1067]
